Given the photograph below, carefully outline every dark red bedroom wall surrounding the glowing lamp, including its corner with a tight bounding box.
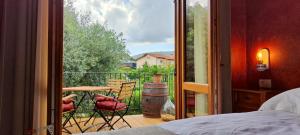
[232,0,300,90]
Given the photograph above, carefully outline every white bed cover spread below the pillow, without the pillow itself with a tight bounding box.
[160,111,300,135]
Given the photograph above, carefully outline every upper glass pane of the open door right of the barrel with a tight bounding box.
[184,0,209,84]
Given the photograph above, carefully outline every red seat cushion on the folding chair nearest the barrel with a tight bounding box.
[96,101,127,111]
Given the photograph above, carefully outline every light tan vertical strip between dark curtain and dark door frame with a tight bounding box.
[33,0,48,135]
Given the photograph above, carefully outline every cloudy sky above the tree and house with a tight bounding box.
[73,0,175,55]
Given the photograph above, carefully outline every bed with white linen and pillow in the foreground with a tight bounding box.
[78,88,300,135]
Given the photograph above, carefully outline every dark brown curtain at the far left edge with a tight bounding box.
[0,0,38,135]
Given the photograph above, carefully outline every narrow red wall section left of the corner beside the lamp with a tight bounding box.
[231,0,247,88]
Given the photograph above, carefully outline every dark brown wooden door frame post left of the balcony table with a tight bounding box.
[47,0,64,135]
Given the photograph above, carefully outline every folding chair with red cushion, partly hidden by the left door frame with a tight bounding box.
[62,94,82,134]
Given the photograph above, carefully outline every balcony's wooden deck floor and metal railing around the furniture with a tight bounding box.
[63,72,175,133]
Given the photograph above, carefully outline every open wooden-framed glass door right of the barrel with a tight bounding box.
[177,0,213,118]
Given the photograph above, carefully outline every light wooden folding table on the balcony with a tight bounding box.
[63,86,114,133]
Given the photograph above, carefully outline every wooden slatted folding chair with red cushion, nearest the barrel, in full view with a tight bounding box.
[94,82,136,131]
